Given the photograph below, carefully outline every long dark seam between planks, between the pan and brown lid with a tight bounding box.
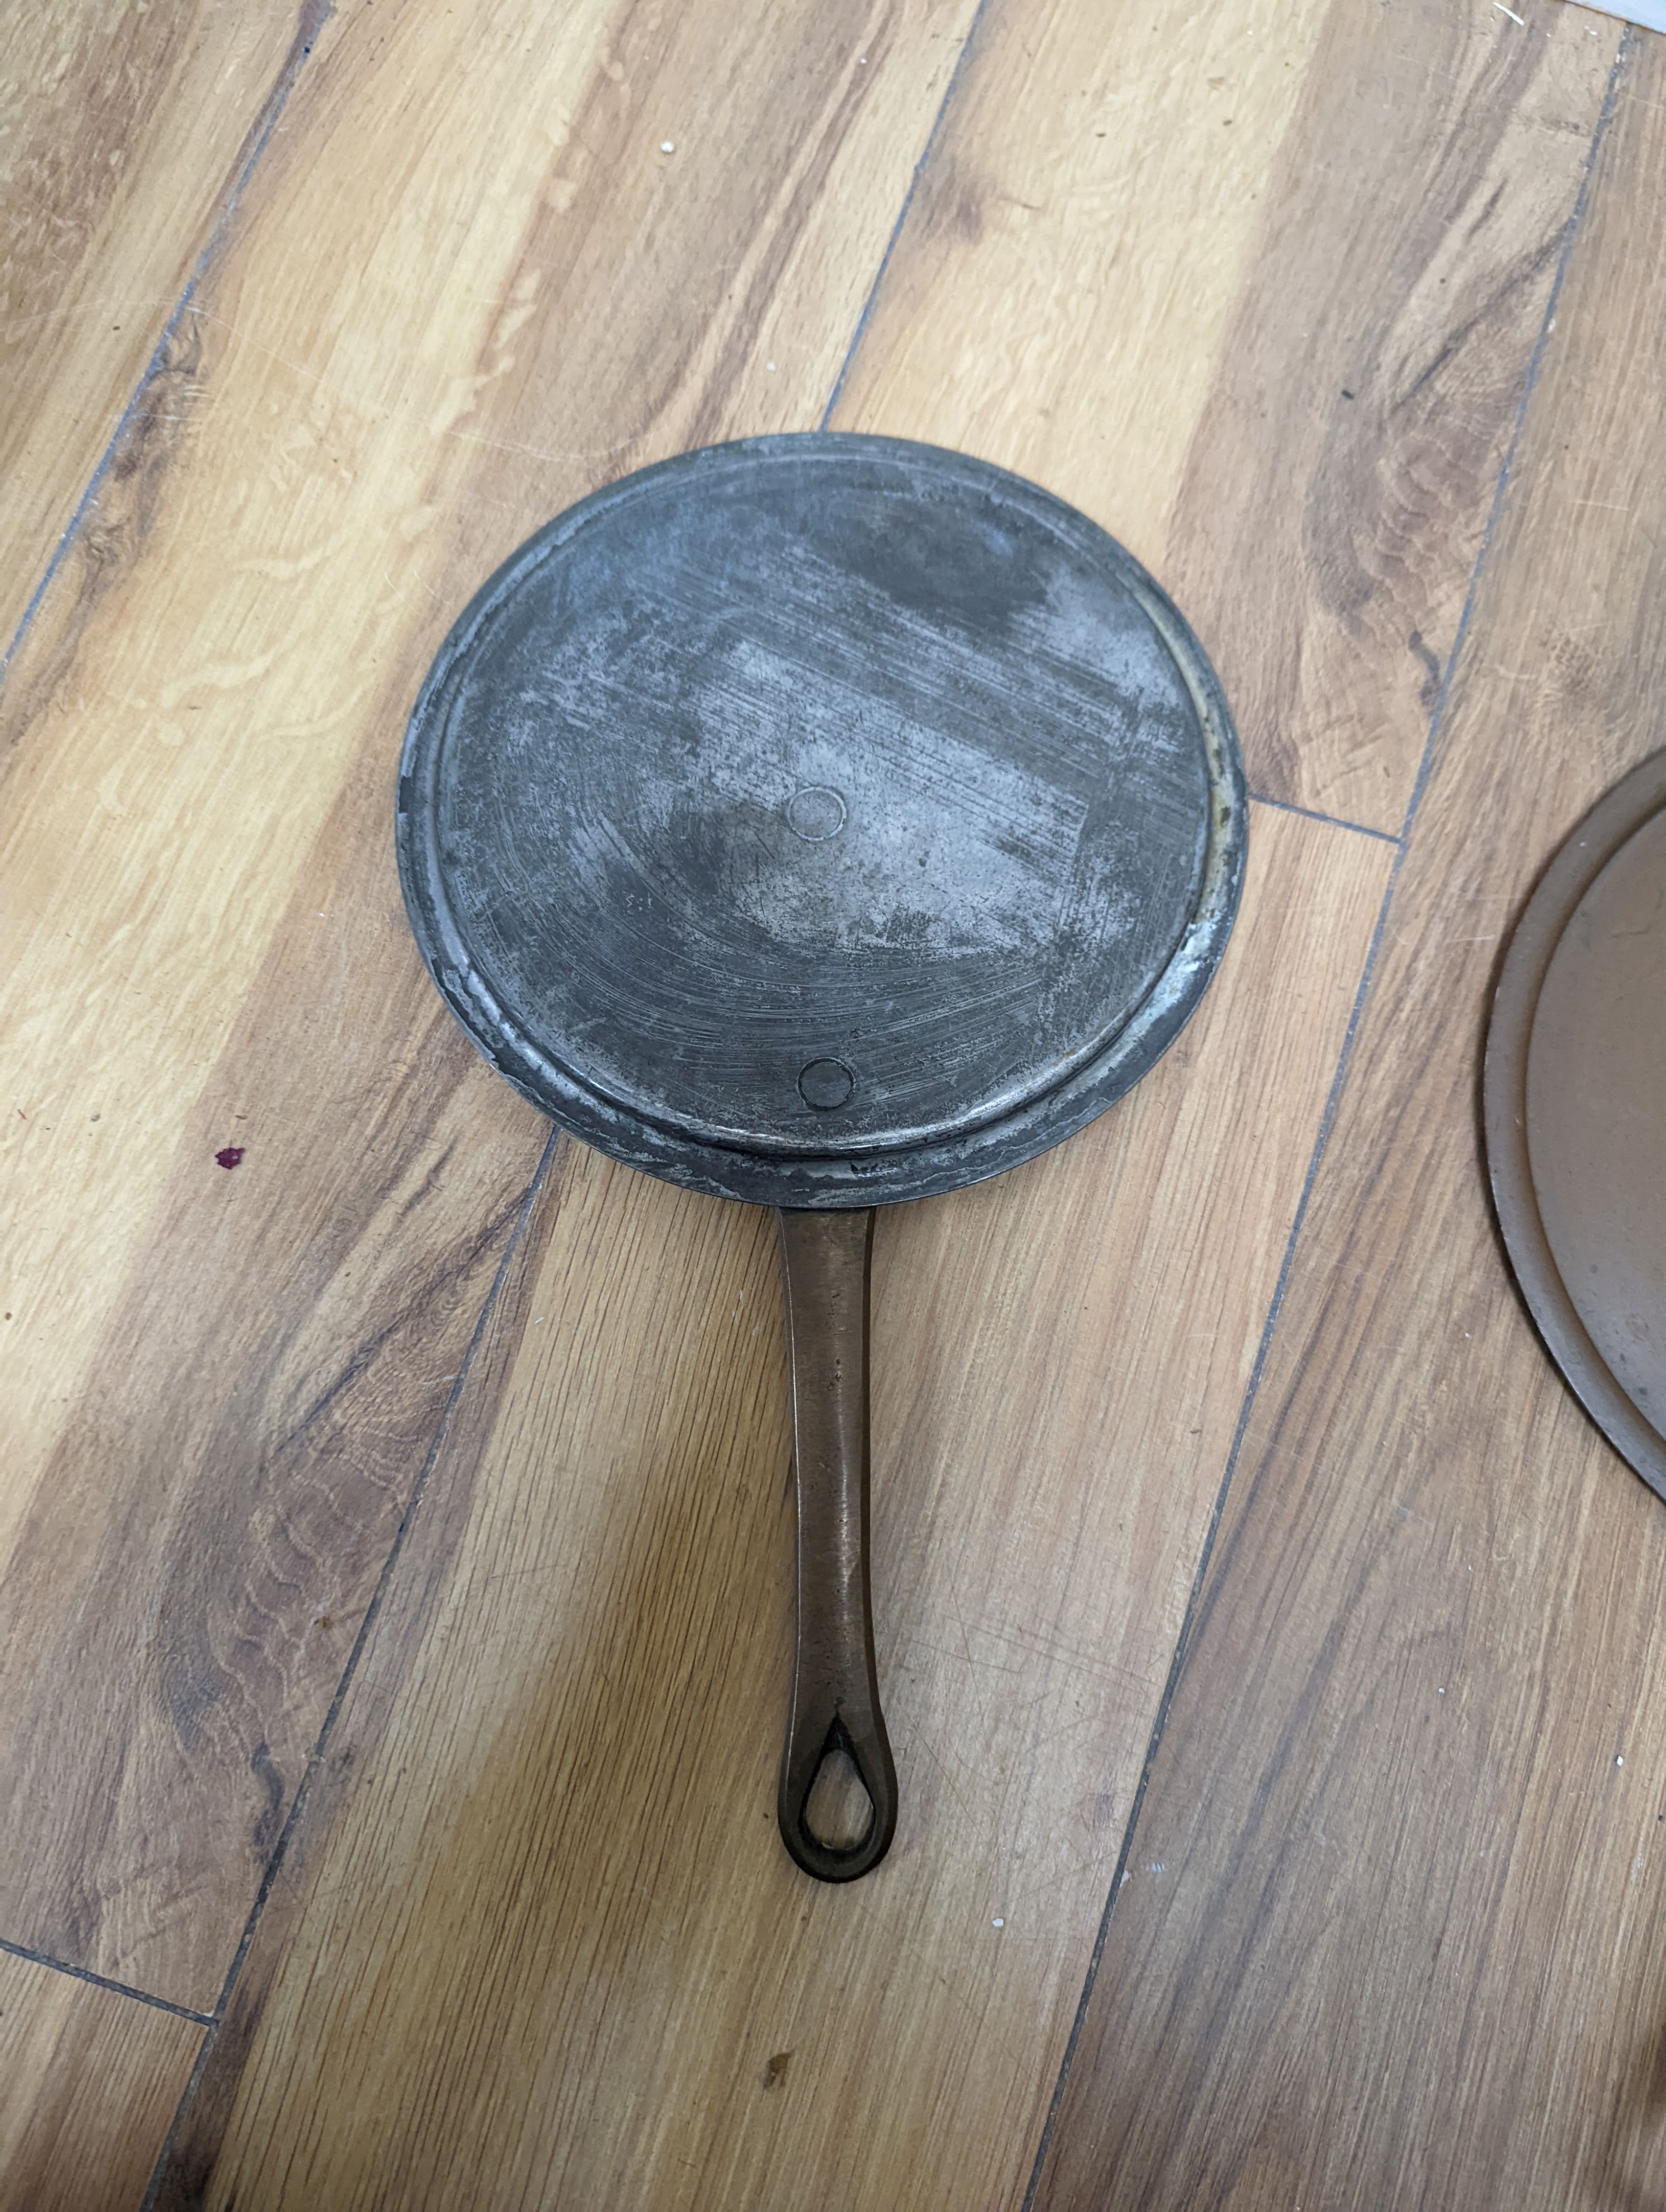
[1022,27,1635,2212]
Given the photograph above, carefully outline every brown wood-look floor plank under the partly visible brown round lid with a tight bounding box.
[1038,36,1666,2212]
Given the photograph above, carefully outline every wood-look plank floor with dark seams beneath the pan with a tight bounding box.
[0,0,1666,2212]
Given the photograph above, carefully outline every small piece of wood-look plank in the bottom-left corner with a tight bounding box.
[0,1951,204,2212]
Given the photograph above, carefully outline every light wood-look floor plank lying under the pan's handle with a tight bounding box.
[162,810,1389,2208]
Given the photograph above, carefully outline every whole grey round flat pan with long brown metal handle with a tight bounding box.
[396,434,1246,1882]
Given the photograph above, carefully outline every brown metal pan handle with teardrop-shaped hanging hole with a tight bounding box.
[776,1208,896,1882]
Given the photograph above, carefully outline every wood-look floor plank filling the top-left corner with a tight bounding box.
[0,0,325,652]
